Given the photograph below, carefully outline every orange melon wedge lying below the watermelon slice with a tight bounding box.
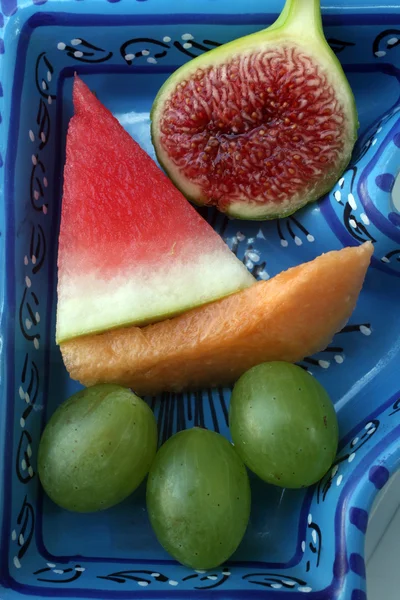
[61,243,373,395]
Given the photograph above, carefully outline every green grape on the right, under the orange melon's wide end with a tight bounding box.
[229,362,338,488]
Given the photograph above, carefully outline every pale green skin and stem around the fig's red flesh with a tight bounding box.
[150,0,359,221]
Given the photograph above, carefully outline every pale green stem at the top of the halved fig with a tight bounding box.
[270,0,324,37]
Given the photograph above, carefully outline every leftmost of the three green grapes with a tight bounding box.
[38,384,157,512]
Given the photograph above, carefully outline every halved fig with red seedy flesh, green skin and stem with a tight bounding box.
[151,0,358,220]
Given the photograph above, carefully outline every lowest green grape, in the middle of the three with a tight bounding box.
[147,428,250,569]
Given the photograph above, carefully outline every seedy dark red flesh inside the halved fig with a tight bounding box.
[160,45,348,210]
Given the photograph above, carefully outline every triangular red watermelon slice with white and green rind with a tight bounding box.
[56,77,254,343]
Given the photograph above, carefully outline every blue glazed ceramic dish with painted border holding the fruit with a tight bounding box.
[0,0,400,600]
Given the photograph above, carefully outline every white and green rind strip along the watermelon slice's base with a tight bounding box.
[57,247,255,343]
